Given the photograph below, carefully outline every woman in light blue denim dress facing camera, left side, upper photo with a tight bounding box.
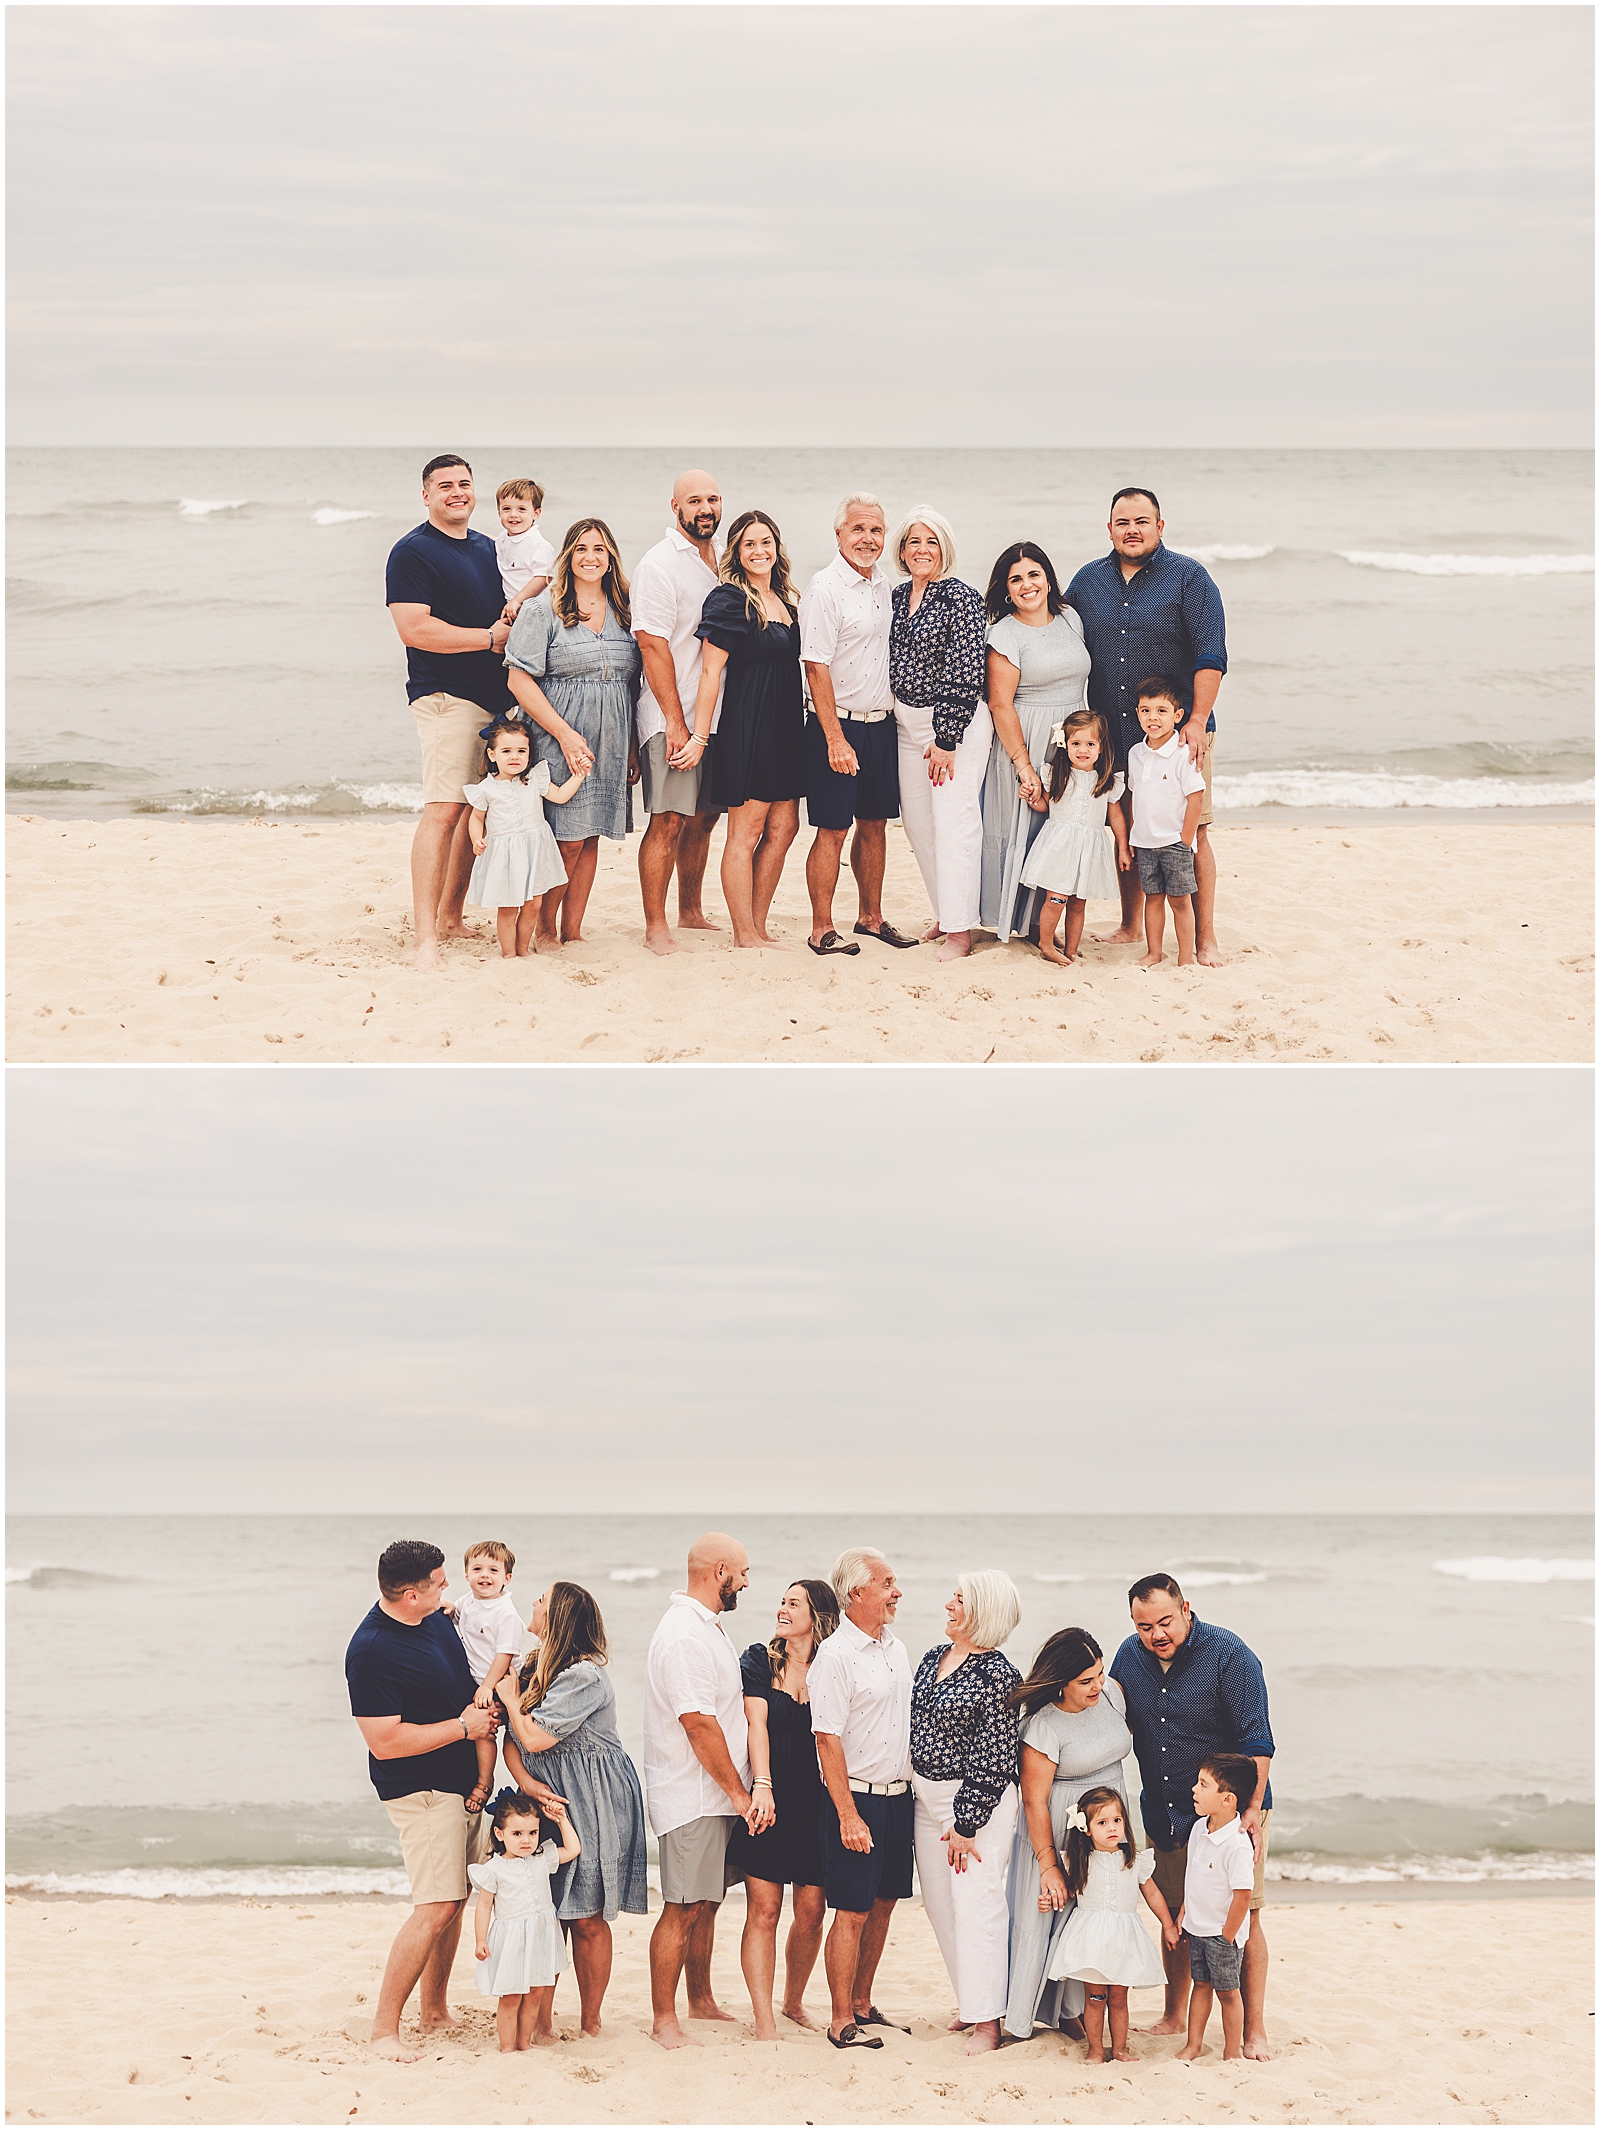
[505,518,639,948]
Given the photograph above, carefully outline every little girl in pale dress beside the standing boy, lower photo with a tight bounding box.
[1048,1783,1178,2064]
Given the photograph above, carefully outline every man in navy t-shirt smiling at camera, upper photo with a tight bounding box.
[383,452,516,969]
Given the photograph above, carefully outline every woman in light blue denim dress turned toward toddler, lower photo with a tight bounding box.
[496,1576,648,2034]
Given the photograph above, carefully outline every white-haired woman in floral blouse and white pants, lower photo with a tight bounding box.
[912,1568,1023,2055]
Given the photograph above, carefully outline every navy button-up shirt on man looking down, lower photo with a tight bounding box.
[1112,1617,1274,1849]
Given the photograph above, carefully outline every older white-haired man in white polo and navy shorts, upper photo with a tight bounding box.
[799,494,916,954]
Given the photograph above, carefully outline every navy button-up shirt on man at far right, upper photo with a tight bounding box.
[1067,545,1227,763]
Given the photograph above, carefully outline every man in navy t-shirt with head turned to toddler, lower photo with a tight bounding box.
[345,1538,499,2064]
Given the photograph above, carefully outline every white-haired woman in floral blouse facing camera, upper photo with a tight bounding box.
[888,509,995,961]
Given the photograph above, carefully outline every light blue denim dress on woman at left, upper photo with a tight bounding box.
[505,592,639,843]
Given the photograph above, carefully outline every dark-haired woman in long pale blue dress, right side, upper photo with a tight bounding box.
[978,539,1089,944]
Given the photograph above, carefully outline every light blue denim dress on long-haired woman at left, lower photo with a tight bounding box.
[505,1661,648,1923]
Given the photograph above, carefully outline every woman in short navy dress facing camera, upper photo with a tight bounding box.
[684,511,805,946]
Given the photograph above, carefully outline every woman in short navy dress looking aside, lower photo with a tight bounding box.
[728,1576,839,2041]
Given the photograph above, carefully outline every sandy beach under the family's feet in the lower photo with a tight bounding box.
[6,1896,1594,2124]
